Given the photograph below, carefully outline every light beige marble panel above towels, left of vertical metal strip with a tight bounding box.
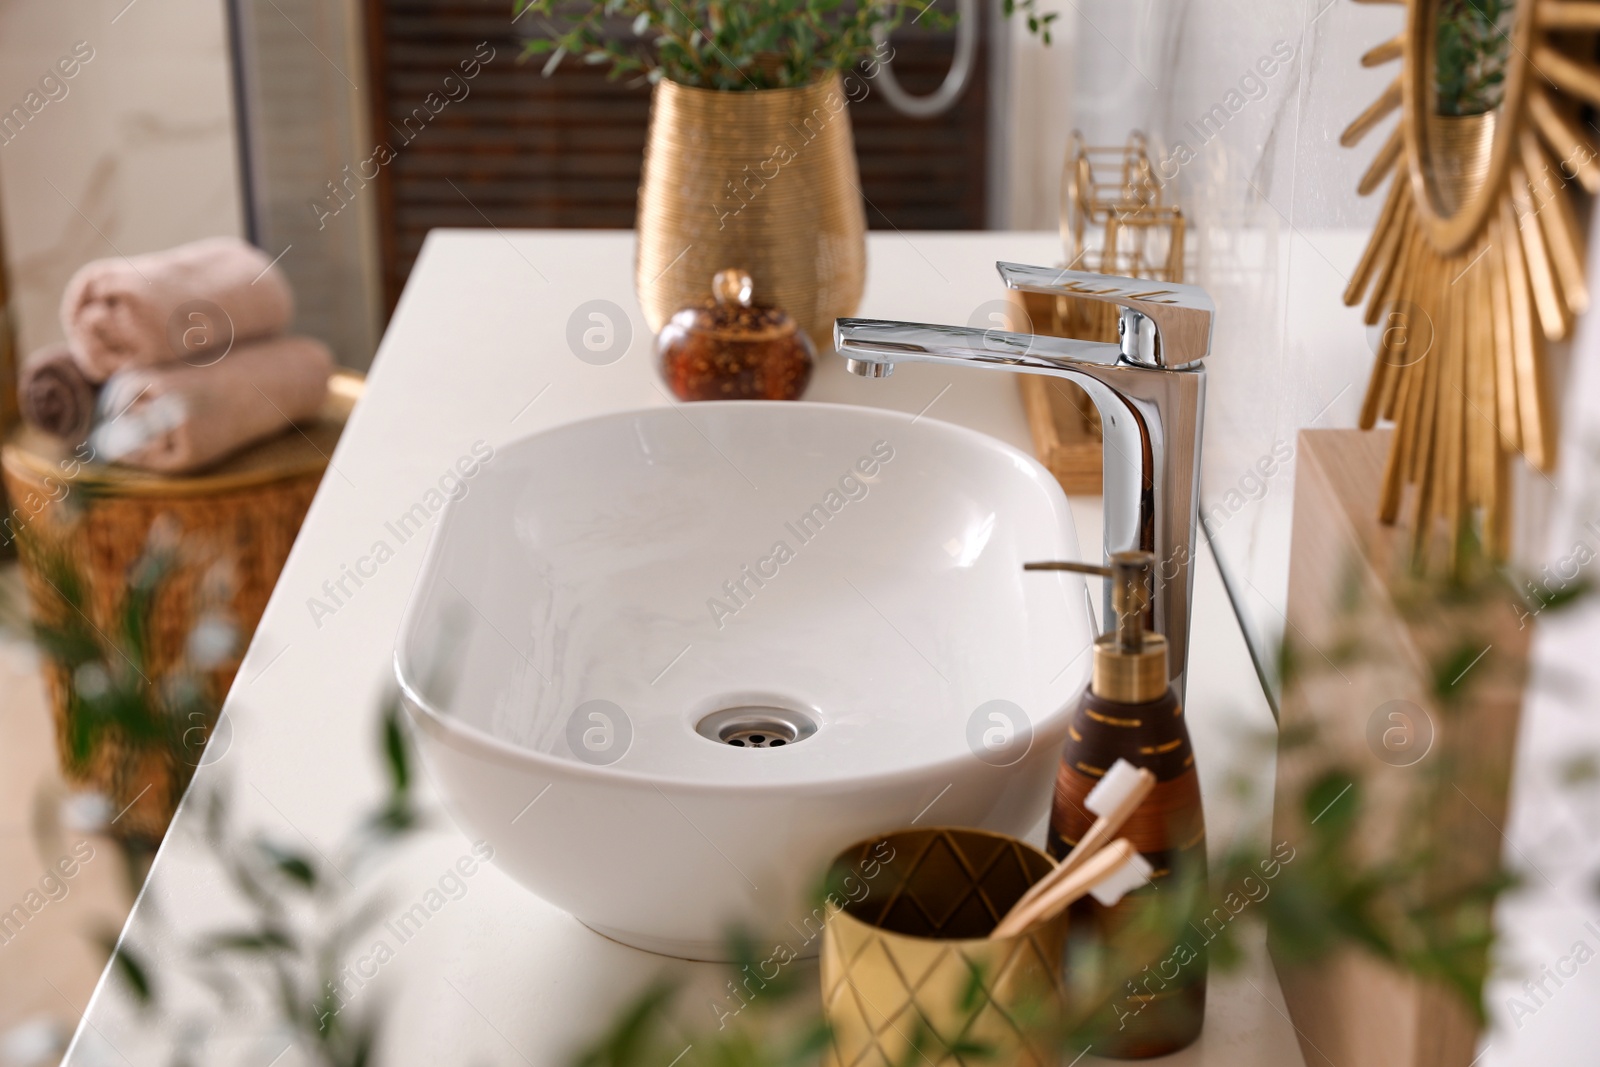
[0,0,243,352]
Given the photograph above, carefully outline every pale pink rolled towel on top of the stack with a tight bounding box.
[61,237,294,382]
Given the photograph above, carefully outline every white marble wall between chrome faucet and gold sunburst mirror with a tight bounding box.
[1074,0,1472,681]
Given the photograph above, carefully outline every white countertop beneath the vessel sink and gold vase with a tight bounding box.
[67,230,1302,1067]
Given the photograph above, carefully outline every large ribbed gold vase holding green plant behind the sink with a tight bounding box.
[635,74,867,350]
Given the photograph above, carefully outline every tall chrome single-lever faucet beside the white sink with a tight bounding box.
[834,262,1214,699]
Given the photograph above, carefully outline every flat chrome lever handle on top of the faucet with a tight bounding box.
[995,261,1216,366]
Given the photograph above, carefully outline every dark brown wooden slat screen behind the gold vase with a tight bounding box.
[366,0,989,307]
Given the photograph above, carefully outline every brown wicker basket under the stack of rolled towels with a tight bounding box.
[0,371,362,840]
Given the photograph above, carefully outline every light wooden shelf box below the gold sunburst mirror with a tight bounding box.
[1272,430,1533,1067]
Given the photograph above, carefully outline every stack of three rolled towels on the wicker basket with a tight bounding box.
[18,244,333,474]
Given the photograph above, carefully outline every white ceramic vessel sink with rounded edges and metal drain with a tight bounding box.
[395,403,1091,960]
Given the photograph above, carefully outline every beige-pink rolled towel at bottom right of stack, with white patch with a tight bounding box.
[91,338,333,474]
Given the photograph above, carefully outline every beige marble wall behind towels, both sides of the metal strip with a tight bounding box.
[0,0,382,366]
